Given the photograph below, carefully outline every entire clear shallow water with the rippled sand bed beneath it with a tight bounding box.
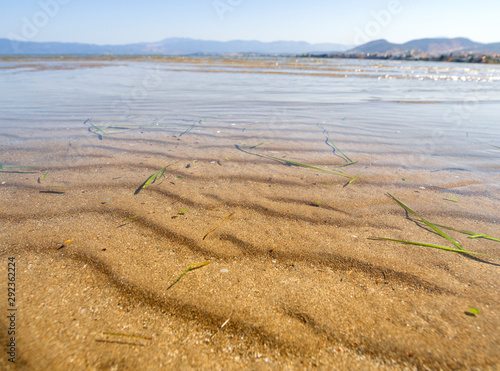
[0,58,500,370]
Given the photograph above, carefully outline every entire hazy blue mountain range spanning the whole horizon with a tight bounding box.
[0,38,500,55]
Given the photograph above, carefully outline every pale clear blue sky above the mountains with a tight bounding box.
[0,0,500,45]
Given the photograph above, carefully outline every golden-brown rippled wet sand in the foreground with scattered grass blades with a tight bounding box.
[0,122,500,370]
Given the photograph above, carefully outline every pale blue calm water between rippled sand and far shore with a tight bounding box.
[0,57,500,173]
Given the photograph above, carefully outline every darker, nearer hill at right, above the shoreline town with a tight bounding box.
[347,37,500,56]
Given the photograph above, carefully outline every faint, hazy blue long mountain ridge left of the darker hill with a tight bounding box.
[0,38,351,55]
